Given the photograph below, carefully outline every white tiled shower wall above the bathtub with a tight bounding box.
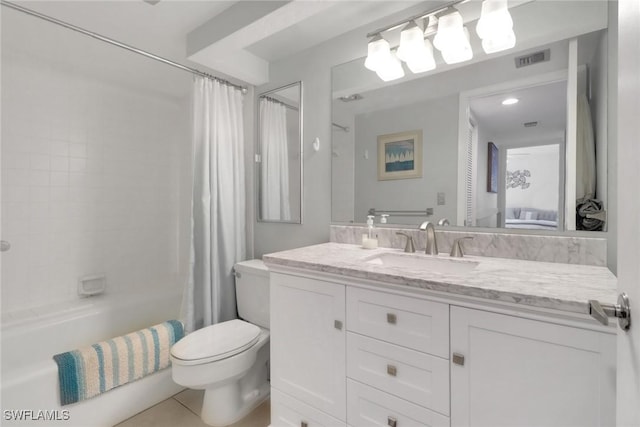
[1,26,190,312]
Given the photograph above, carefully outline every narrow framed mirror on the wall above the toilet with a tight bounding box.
[256,82,303,224]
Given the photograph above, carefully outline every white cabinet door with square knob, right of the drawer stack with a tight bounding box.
[451,307,616,427]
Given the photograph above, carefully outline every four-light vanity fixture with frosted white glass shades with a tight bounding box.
[365,0,516,81]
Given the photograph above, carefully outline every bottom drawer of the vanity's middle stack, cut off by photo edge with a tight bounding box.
[347,380,450,427]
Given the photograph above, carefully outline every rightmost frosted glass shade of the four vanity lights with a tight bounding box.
[476,0,516,53]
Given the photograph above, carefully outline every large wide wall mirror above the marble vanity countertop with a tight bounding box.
[332,0,612,232]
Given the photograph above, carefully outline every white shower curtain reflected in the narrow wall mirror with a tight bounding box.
[260,98,291,221]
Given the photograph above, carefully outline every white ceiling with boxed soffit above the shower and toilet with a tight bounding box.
[6,0,424,85]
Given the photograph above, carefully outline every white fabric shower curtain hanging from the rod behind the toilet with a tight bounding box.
[182,77,246,332]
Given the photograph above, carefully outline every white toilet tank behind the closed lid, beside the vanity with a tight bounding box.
[234,259,269,329]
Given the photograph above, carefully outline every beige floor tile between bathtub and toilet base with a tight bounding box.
[115,399,209,427]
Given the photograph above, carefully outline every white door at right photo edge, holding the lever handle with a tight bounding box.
[617,0,640,426]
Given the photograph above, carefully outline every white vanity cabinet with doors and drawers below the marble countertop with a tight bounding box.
[271,271,616,427]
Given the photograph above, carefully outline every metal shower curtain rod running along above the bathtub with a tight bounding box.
[0,0,247,93]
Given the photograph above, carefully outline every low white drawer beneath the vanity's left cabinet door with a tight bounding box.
[271,388,345,427]
